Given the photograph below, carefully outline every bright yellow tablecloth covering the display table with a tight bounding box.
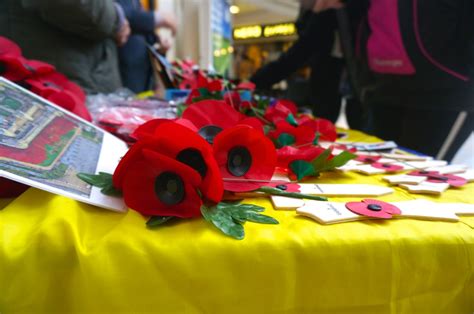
[0,131,474,314]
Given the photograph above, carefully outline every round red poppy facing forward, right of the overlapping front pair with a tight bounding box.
[213,125,276,192]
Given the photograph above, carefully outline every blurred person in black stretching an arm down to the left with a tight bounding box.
[251,0,362,128]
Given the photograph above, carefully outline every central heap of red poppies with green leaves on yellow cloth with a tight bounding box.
[80,82,355,239]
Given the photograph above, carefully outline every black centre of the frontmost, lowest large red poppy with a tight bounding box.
[155,171,185,206]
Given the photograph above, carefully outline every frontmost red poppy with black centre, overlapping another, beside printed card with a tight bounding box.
[114,147,202,218]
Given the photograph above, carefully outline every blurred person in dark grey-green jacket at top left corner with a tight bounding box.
[0,0,130,93]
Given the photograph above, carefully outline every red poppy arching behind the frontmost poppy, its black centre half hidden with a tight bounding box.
[114,122,224,203]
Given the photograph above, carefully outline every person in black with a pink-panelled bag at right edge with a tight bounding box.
[347,0,474,160]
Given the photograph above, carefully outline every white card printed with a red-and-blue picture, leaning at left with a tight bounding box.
[0,77,128,212]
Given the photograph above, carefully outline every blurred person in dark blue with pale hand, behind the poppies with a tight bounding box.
[117,0,176,93]
